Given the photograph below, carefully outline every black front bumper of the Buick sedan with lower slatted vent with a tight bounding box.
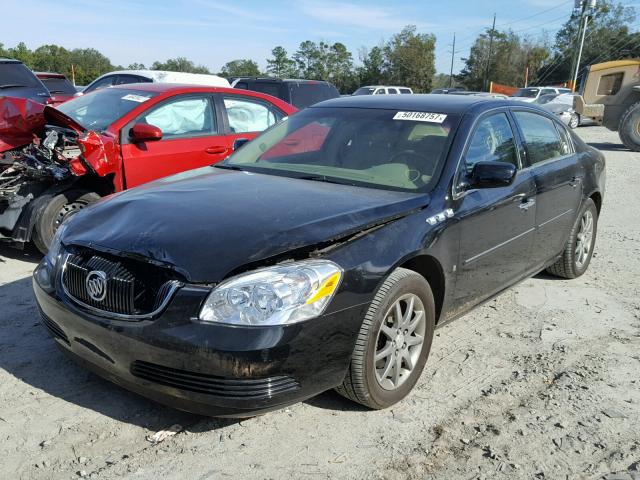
[33,264,368,417]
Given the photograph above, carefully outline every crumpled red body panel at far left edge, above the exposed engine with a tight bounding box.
[0,97,45,153]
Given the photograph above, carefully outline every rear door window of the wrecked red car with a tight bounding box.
[224,97,283,133]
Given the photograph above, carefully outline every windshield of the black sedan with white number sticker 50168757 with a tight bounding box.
[219,108,459,192]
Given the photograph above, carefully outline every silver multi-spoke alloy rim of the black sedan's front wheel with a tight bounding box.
[374,293,426,390]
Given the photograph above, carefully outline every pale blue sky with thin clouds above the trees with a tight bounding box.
[0,0,574,73]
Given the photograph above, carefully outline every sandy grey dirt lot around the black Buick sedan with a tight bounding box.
[0,127,640,480]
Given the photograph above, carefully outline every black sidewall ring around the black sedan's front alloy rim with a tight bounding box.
[364,274,435,408]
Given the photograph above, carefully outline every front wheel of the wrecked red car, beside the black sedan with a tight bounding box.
[33,190,100,254]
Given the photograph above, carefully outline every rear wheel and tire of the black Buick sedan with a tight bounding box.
[547,198,598,278]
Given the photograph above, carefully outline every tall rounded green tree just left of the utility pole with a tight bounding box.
[384,25,436,92]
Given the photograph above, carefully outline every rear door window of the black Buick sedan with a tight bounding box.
[514,111,567,165]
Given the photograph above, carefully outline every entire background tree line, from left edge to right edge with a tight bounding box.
[0,0,640,93]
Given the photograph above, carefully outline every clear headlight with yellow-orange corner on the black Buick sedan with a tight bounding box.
[200,260,342,325]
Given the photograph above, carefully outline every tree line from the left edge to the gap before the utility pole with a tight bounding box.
[0,25,435,93]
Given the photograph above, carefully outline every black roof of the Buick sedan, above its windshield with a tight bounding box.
[310,93,522,114]
